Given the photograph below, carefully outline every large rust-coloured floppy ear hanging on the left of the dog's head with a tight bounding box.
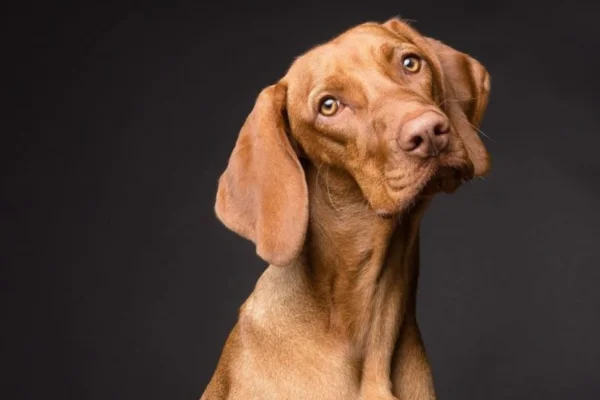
[215,84,308,265]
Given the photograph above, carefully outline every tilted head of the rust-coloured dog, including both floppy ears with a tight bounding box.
[216,19,490,265]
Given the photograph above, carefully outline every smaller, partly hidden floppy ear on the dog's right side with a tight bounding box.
[426,38,490,176]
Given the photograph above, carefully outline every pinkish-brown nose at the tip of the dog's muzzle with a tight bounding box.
[398,111,450,158]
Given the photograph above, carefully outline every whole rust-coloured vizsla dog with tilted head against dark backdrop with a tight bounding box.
[201,19,490,400]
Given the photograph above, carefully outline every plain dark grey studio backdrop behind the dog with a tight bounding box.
[0,0,600,400]
